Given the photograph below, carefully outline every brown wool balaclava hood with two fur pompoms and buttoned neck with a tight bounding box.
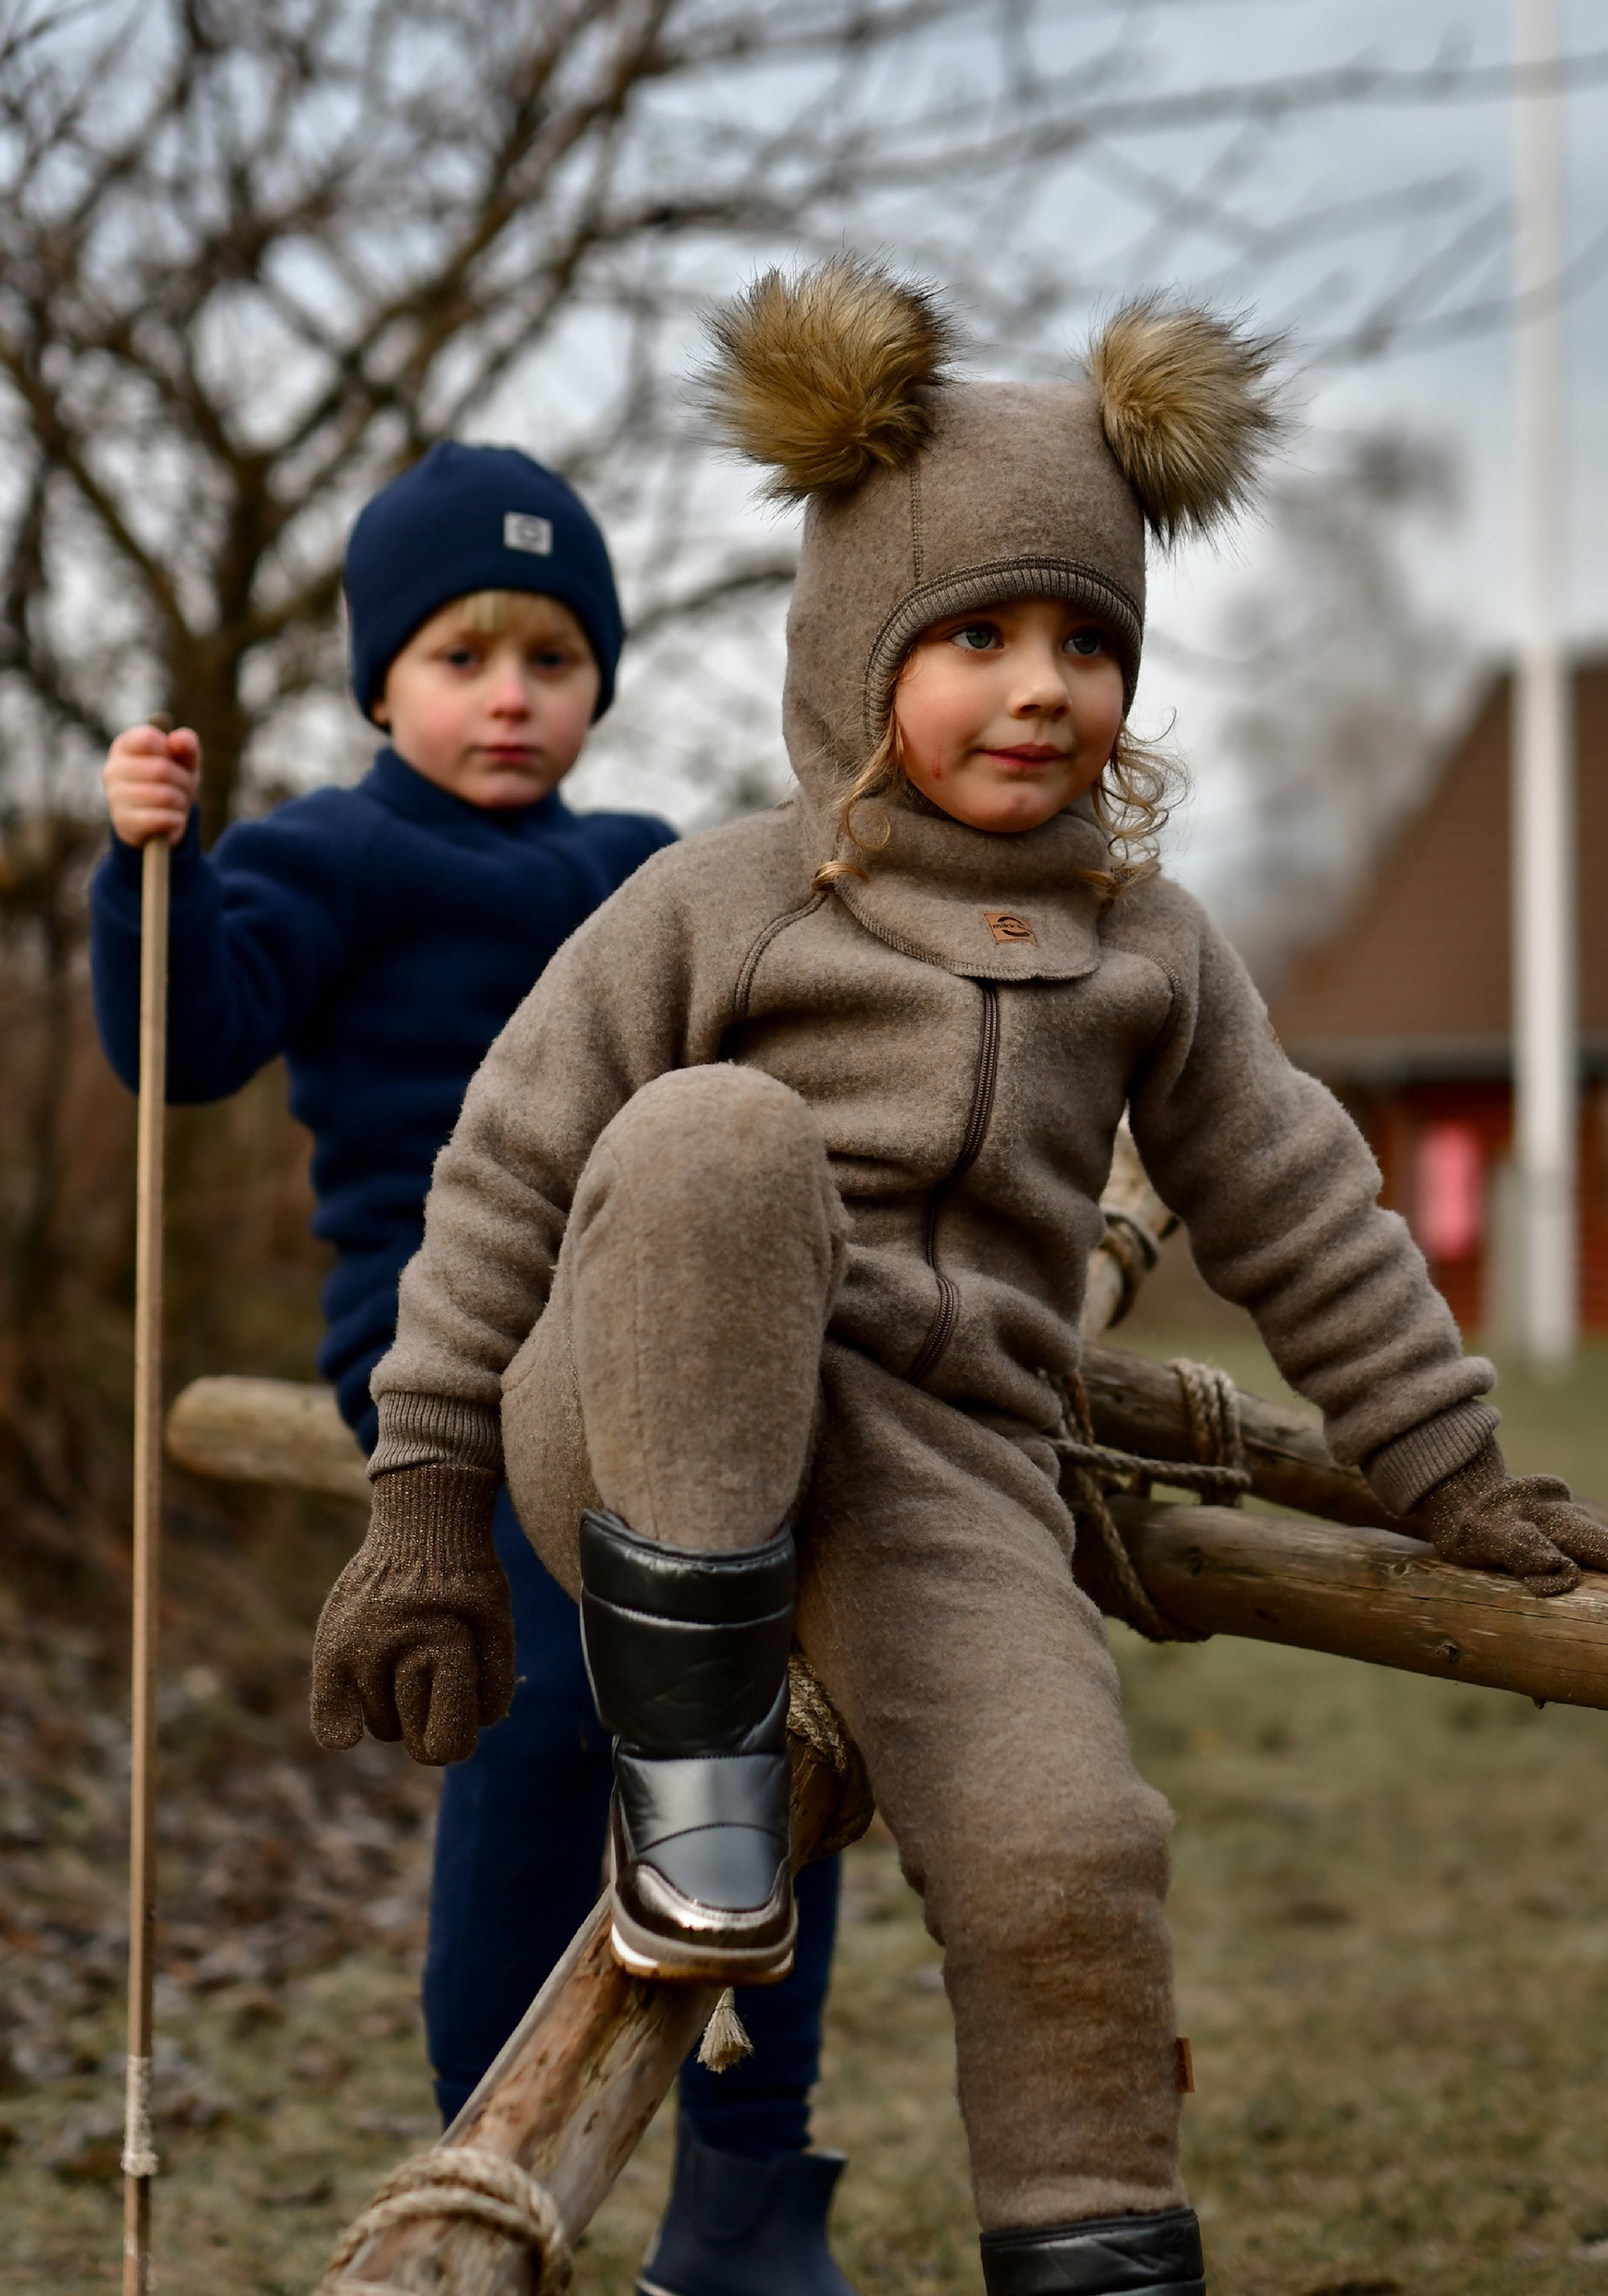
[703,255,1278,981]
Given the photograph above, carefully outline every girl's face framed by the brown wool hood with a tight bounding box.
[893,597,1123,831]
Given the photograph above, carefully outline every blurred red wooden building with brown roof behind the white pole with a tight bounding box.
[1273,662,1608,1331]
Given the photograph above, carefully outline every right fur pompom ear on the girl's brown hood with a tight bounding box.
[1089,296,1284,544]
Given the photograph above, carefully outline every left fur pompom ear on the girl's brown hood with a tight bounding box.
[700,255,956,502]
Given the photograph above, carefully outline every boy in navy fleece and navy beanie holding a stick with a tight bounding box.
[92,441,847,2296]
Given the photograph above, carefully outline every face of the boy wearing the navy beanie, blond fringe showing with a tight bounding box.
[375,595,600,808]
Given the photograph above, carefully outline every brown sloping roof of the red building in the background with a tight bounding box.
[1273,662,1608,1081]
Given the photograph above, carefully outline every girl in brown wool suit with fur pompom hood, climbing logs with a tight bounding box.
[314,260,1608,2296]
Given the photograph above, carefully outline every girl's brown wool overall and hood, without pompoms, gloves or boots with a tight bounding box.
[372,367,1495,2229]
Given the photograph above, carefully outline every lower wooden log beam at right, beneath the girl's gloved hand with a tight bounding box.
[1112,1499,1608,1708]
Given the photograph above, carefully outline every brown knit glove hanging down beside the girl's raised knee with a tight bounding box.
[313,1465,515,1763]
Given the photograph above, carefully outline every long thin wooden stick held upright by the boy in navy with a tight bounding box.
[121,813,170,2296]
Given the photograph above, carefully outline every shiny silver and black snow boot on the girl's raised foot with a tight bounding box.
[581,1511,797,1986]
